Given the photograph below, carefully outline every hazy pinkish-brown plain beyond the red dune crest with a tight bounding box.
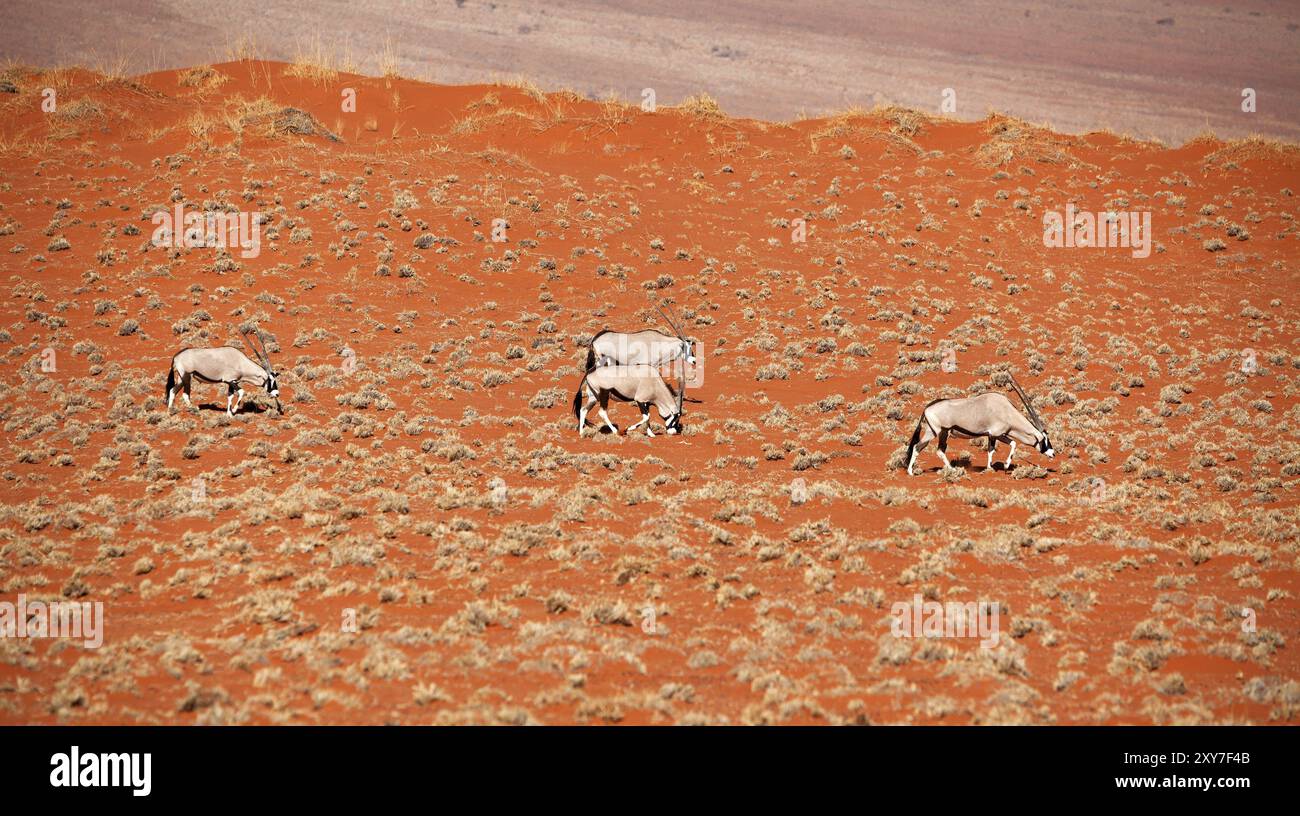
[0,0,1300,143]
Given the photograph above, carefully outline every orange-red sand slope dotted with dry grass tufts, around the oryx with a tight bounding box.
[0,62,1300,722]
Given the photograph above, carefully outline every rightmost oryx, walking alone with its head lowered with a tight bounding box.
[907,377,1056,476]
